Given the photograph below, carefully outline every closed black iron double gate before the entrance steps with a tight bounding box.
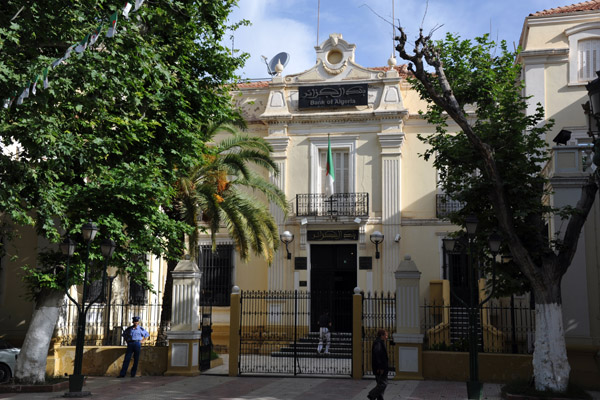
[238,290,352,377]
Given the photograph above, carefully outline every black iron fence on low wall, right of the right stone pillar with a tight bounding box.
[422,299,535,354]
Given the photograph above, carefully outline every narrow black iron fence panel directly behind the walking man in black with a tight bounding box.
[362,293,396,377]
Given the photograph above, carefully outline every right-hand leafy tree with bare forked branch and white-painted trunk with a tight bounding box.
[396,29,598,391]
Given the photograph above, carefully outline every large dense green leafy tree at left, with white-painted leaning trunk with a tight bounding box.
[0,0,245,382]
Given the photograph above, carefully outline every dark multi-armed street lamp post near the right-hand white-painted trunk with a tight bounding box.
[443,216,502,399]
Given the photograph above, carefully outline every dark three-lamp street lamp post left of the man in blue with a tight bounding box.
[60,221,116,397]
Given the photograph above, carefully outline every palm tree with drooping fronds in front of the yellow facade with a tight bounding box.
[157,124,287,344]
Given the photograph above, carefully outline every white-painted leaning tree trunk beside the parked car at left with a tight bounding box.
[15,291,65,384]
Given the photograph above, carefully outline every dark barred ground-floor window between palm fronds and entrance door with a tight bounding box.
[198,245,233,306]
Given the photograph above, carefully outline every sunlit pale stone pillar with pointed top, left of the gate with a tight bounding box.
[165,260,202,376]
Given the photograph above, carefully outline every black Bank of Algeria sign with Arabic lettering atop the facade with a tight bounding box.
[298,83,369,109]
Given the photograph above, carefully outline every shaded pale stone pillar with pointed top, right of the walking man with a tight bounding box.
[392,255,423,379]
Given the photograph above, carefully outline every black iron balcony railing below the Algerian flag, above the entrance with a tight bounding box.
[296,193,369,217]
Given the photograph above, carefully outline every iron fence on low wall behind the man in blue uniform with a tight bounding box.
[57,303,162,346]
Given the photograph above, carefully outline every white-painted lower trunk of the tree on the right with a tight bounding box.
[533,303,571,392]
